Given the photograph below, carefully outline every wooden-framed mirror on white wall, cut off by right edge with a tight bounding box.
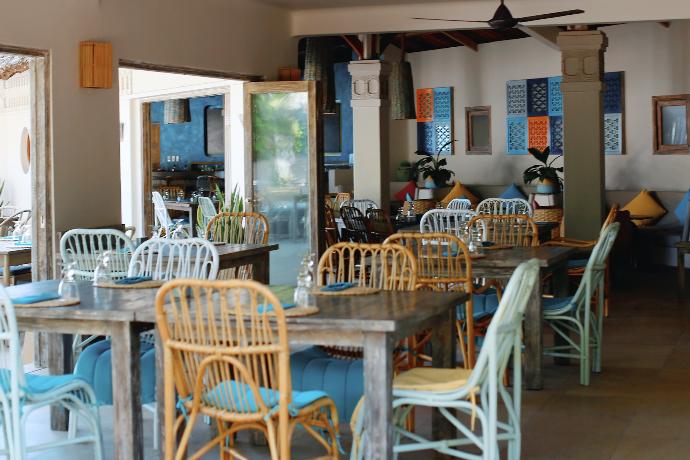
[652,94,690,154]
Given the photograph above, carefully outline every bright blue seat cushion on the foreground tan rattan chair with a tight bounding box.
[201,380,328,415]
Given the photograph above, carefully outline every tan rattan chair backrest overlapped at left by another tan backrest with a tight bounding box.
[384,233,472,292]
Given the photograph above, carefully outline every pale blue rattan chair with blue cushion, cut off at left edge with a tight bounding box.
[0,286,103,460]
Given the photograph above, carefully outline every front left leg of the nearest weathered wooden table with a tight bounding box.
[112,322,144,460]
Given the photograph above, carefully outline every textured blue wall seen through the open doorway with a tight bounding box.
[151,96,224,169]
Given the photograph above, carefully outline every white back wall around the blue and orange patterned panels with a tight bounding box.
[390,21,690,191]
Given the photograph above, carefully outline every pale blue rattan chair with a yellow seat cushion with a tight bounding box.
[351,259,539,460]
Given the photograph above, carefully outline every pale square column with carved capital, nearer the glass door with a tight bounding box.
[348,60,390,210]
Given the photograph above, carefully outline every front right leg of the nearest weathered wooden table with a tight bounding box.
[364,332,393,460]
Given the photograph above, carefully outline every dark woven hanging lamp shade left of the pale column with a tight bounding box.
[303,37,336,114]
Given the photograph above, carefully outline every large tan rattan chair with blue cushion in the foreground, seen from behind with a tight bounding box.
[156,280,338,460]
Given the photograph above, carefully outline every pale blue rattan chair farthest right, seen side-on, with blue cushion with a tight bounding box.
[543,222,620,385]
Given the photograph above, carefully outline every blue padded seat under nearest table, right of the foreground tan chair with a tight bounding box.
[290,347,364,421]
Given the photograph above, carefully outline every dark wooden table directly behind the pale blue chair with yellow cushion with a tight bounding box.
[472,246,576,390]
